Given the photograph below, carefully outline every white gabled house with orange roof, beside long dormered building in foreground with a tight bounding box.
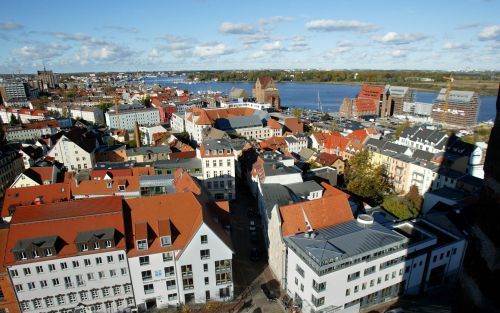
[126,193,233,311]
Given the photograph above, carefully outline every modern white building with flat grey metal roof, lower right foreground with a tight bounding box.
[285,215,466,313]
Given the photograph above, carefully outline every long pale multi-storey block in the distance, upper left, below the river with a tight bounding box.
[105,105,161,130]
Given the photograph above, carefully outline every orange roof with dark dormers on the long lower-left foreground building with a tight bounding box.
[5,197,125,264]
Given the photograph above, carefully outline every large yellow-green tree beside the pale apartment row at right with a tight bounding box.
[345,150,391,204]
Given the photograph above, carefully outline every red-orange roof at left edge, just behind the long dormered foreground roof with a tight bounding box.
[2,183,71,217]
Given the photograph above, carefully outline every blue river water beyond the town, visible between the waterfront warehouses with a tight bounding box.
[144,77,496,122]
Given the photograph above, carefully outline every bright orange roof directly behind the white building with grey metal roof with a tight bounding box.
[279,191,354,237]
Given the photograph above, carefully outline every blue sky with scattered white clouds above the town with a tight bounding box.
[0,0,500,73]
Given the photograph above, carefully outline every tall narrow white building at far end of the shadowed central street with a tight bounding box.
[197,139,237,200]
